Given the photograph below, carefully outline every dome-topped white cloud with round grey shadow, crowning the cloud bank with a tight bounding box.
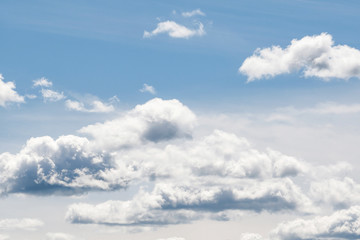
[80,98,196,149]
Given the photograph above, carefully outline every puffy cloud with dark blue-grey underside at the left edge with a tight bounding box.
[0,135,131,195]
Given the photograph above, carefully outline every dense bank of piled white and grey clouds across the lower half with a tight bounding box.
[0,98,360,236]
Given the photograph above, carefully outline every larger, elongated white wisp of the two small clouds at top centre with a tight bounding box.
[143,21,205,39]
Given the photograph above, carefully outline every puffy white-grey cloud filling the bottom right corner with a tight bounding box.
[270,206,360,240]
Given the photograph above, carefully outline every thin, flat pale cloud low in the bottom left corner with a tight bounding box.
[0,218,44,230]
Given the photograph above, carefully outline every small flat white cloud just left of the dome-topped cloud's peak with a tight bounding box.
[65,100,115,113]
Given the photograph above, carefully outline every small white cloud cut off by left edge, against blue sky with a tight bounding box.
[0,74,25,107]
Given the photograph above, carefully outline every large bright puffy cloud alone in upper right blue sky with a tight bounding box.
[239,33,360,82]
